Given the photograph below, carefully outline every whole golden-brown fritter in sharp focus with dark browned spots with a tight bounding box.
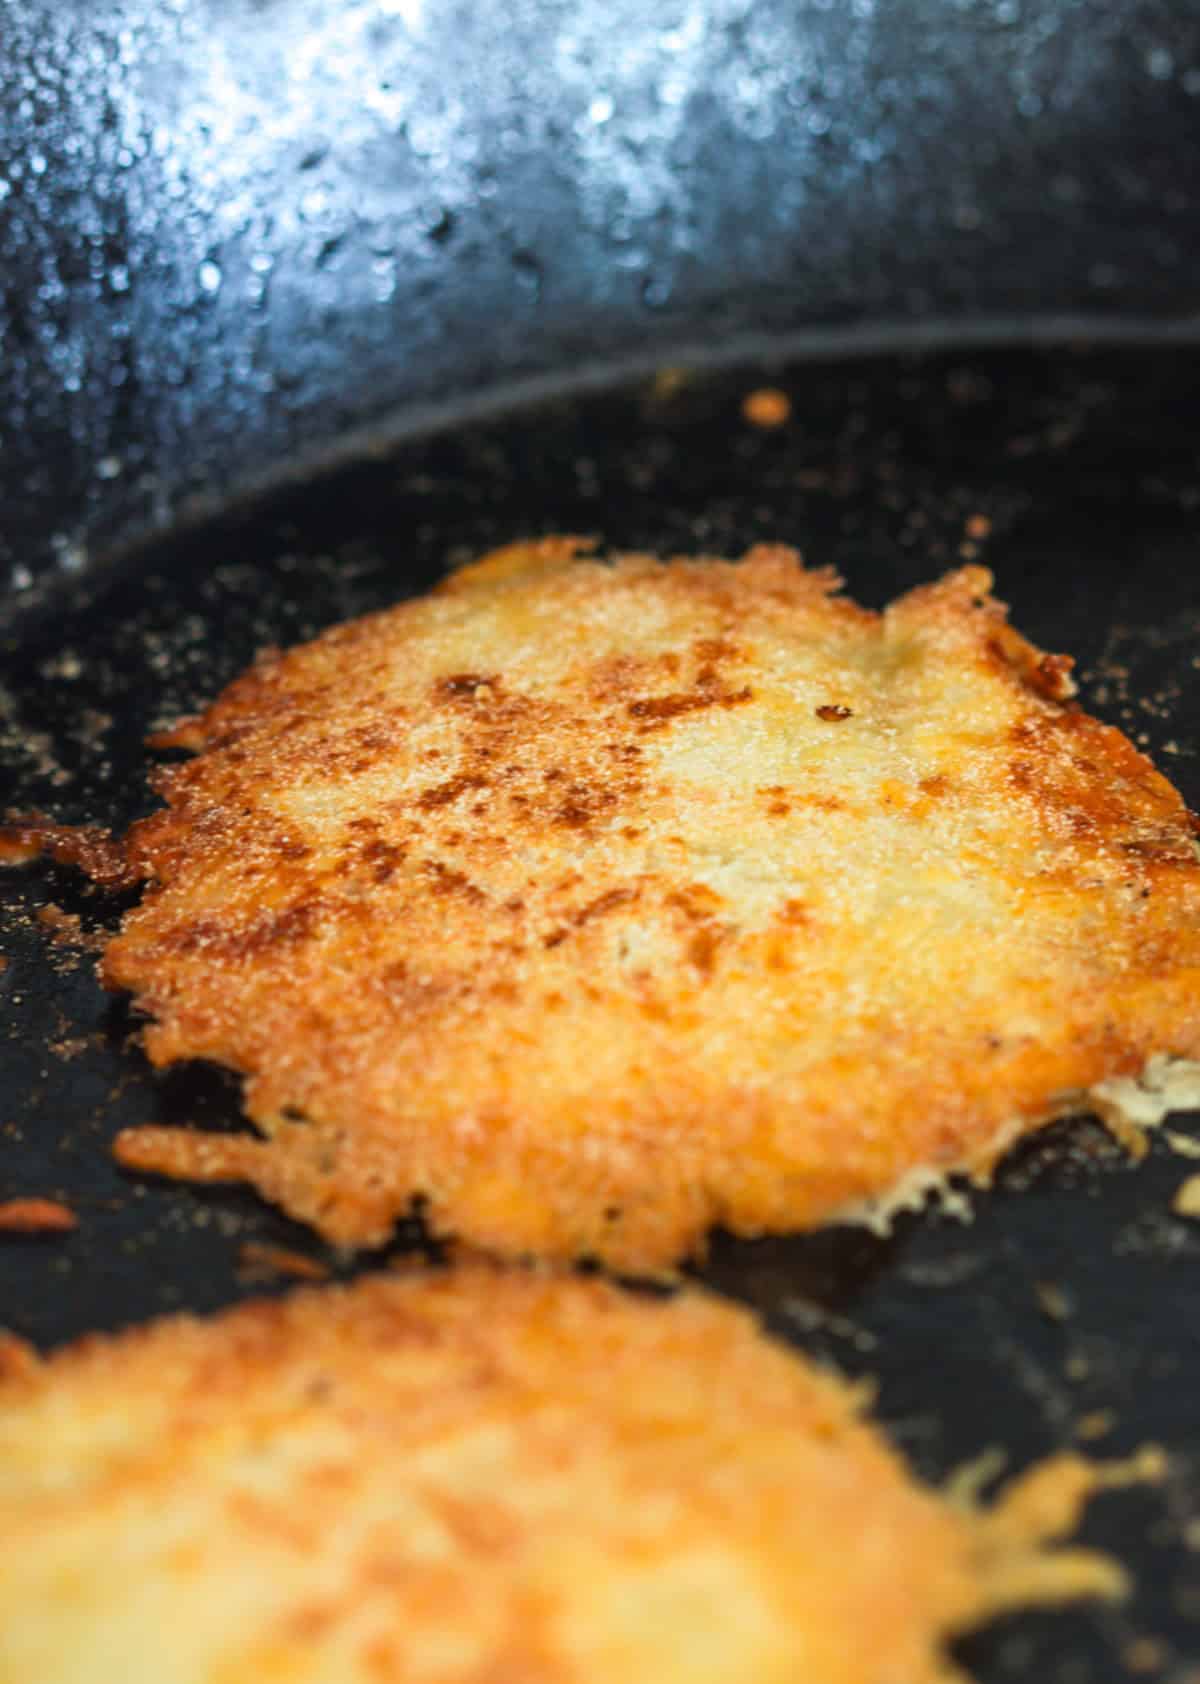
[103,539,1200,1270]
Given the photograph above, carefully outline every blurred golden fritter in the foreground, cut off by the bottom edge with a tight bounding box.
[0,1265,1144,1684]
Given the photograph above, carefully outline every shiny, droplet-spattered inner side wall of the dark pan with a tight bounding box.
[0,0,1200,606]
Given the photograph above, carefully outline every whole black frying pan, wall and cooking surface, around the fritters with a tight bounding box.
[0,0,1200,1684]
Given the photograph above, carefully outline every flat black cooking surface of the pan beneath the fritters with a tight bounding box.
[0,347,1200,1684]
